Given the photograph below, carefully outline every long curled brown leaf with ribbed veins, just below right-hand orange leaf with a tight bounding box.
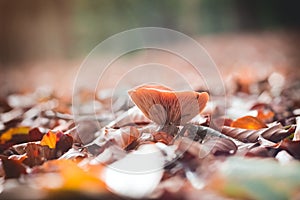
[222,124,293,142]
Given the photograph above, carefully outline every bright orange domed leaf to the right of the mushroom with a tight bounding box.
[230,116,267,130]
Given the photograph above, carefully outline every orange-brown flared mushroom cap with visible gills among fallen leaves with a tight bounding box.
[128,85,209,125]
